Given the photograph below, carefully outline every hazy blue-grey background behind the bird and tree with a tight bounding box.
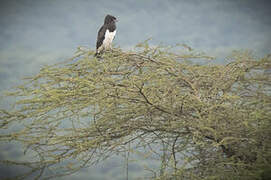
[0,0,271,179]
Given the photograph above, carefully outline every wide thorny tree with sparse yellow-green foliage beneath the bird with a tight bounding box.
[0,42,271,179]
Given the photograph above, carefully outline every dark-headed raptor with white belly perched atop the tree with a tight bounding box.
[95,15,117,56]
